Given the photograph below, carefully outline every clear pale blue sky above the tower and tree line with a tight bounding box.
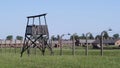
[0,0,120,39]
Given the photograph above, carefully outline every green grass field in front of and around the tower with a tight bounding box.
[0,46,120,68]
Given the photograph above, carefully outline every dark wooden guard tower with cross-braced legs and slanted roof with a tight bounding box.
[21,14,53,57]
